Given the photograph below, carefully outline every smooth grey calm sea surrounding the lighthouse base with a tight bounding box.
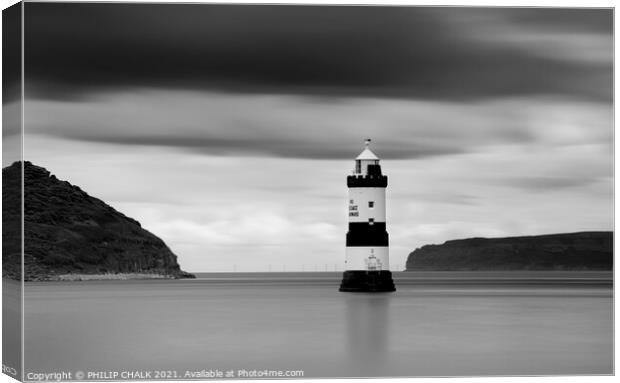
[17,272,613,378]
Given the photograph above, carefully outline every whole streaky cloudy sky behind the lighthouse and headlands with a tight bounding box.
[3,3,613,271]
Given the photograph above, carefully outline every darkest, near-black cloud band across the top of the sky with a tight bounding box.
[18,3,613,102]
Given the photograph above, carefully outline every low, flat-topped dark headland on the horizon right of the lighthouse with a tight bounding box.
[407,232,613,271]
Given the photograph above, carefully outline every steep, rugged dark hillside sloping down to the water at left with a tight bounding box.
[2,162,193,280]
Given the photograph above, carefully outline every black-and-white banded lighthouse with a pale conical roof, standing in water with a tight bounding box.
[340,139,396,292]
